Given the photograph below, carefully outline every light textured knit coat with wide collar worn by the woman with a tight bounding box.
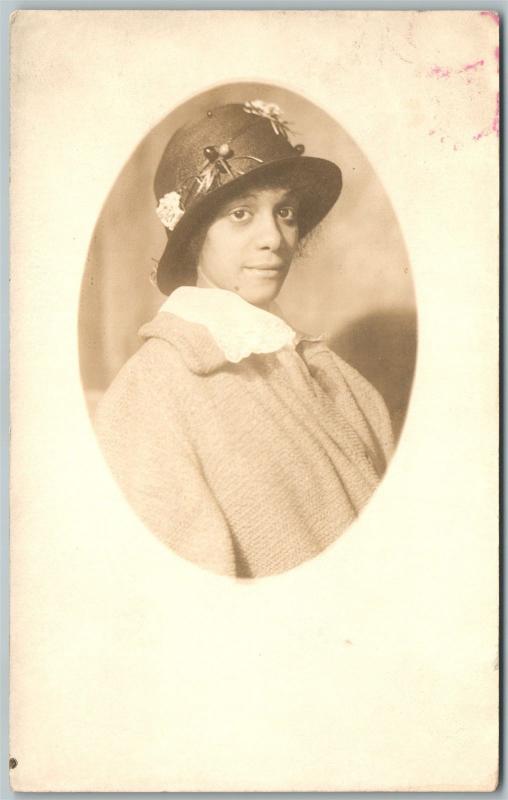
[96,312,392,578]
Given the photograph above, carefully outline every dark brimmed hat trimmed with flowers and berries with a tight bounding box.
[154,100,342,294]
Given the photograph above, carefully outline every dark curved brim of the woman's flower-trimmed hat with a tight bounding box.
[156,156,342,294]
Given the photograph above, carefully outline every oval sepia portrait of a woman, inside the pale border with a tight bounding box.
[80,83,416,578]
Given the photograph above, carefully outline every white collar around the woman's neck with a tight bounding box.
[160,286,322,364]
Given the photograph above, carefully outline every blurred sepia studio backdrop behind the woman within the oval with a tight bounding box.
[79,82,416,436]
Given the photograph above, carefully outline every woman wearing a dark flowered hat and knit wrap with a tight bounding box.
[97,101,392,578]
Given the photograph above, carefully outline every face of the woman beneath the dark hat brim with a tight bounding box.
[197,188,298,307]
